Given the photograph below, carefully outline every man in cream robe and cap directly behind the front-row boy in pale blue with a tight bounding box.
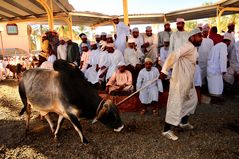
[142,26,158,63]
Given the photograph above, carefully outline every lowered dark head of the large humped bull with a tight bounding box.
[93,100,124,132]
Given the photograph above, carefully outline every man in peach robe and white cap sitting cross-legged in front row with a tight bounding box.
[106,62,133,95]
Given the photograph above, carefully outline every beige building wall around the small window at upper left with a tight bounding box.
[0,23,29,52]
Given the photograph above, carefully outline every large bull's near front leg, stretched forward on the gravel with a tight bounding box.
[67,113,89,144]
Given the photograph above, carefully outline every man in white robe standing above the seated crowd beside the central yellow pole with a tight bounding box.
[113,18,130,53]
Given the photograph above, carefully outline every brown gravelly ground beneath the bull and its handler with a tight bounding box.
[0,79,239,159]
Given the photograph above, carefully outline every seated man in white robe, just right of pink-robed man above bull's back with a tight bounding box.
[85,42,101,84]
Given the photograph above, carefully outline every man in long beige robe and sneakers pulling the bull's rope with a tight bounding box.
[160,28,202,140]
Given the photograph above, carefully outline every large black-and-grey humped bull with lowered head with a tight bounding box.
[19,60,124,144]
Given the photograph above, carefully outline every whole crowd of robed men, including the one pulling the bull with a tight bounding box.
[0,18,239,140]
